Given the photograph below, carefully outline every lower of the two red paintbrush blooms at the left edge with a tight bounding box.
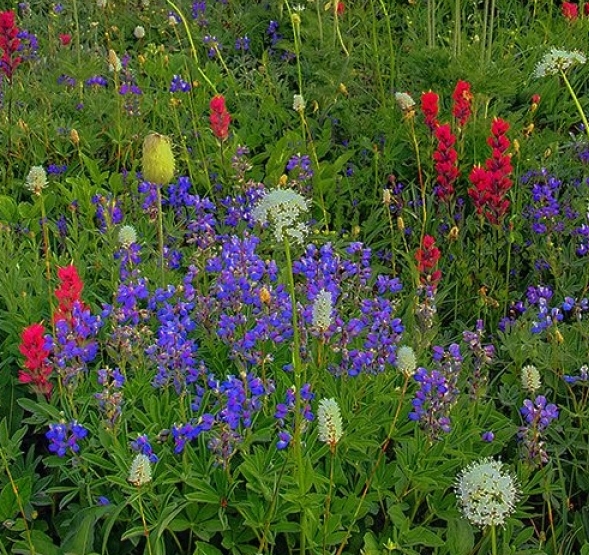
[18,324,53,398]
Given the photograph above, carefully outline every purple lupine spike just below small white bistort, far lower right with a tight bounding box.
[518,395,559,466]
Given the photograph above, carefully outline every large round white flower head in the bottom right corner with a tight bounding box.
[456,458,518,527]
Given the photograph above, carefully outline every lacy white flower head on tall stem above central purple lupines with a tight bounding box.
[252,189,309,244]
